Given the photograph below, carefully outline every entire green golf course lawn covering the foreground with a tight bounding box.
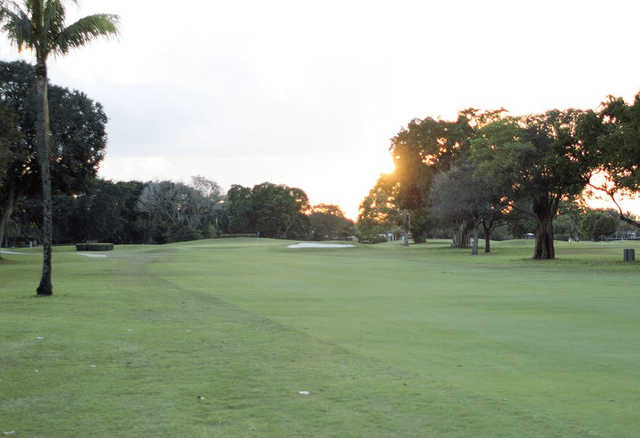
[0,239,640,438]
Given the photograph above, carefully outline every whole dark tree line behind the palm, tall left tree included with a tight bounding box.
[0,61,354,250]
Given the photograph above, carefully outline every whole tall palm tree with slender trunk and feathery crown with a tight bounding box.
[0,0,118,296]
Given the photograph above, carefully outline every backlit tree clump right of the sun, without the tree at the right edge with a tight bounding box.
[358,105,600,259]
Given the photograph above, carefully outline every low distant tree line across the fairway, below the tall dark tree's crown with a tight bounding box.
[4,176,354,246]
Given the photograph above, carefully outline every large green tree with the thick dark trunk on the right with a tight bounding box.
[471,110,591,259]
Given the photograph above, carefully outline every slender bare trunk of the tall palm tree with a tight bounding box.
[36,60,53,296]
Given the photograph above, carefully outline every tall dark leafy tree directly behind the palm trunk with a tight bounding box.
[0,61,107,255]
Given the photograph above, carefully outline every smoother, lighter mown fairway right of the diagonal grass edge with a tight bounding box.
[151,243,640,436]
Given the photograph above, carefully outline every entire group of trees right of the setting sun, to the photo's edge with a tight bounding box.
[358,102,640,259]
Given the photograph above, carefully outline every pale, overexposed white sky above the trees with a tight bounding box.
[0,0,640,219]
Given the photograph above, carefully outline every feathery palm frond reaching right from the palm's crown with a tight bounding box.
[51,14,119,54]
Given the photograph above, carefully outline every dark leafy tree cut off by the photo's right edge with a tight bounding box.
[578,93,640,228]
